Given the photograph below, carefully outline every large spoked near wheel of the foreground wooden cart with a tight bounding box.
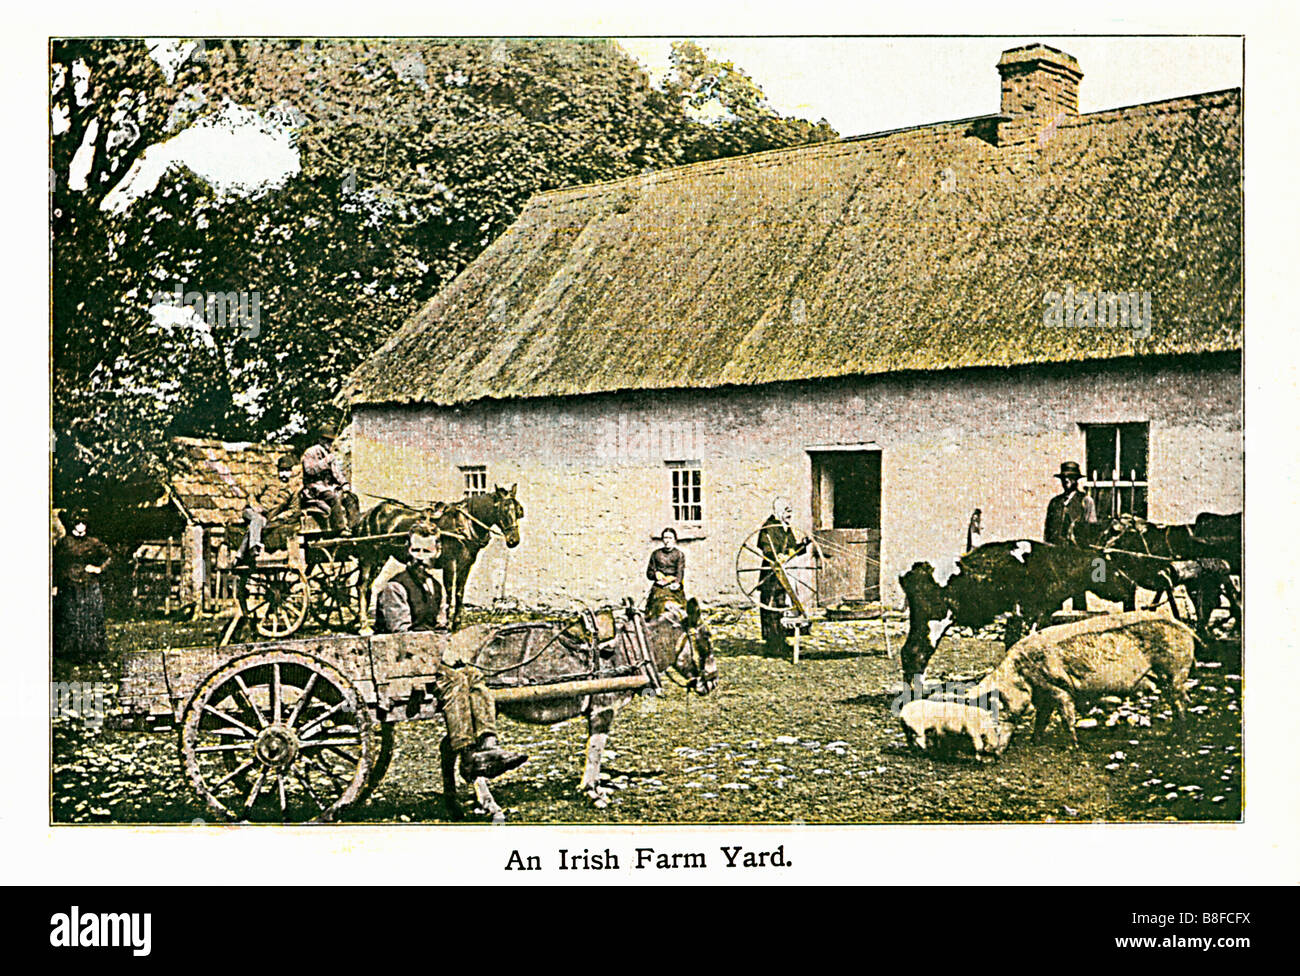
[181,651,382,823]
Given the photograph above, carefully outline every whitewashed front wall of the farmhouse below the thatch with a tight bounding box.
[352,356,1244,606]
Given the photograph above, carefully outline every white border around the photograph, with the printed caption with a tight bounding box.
[10,0,1300,885]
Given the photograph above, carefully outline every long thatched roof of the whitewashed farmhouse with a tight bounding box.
[348,83,1242,404]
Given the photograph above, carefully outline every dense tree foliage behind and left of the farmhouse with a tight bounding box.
[51,39,835,512]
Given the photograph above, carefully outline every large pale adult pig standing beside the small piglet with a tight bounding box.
[966,610,1196,747]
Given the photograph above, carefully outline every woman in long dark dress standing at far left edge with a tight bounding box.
[55,512,109,660]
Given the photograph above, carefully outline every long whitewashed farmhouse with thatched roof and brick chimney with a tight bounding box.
[347,44,1243,606]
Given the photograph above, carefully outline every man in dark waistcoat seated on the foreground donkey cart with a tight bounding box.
[374,522,528,781]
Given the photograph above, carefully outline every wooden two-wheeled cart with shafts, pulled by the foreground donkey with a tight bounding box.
[112,623,659,823]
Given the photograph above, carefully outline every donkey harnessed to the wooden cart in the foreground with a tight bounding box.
[441,598,718,820]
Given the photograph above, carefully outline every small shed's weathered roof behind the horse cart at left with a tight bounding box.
[168,437,302,525]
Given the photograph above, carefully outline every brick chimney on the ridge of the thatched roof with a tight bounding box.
[997,44,1083,144]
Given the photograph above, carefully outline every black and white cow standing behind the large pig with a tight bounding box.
[898,539,1134,686]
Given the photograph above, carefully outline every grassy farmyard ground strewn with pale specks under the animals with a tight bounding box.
[51,611,1243,824]
